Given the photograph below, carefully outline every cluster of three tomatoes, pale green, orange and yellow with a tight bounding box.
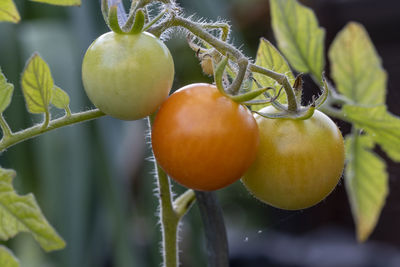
[82,32,344,209]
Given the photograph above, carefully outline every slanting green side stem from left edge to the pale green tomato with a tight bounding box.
[0,109,105,152]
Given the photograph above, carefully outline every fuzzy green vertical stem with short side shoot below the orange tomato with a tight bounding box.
[149,113,195,267]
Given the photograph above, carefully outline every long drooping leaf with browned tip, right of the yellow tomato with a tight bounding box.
[345,134,388,242]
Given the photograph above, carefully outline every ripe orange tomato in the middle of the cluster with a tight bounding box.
[152,83,259,191]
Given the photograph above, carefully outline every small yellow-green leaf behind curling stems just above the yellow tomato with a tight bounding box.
[252,38,295,111]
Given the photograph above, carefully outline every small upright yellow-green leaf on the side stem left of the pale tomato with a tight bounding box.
[22,53,54,113]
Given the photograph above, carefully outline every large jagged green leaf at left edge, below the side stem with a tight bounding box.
[0,168,65,251]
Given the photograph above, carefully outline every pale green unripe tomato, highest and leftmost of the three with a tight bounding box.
[82,32,174,120]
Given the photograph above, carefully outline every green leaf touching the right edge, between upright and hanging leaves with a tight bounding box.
[343,105,400,162]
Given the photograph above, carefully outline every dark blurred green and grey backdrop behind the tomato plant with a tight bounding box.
[0,0,400,267]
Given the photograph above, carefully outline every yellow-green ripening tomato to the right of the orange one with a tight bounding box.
[242,106,344,210]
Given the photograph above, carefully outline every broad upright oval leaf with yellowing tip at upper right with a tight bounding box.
[329,22,387,105]
